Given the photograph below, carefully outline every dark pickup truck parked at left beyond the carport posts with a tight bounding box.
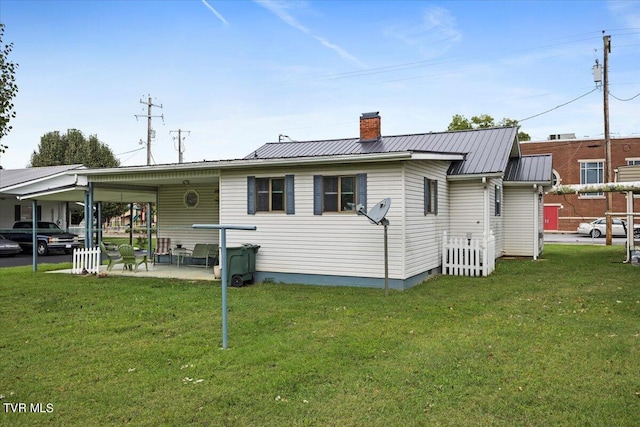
[0,221,84,255]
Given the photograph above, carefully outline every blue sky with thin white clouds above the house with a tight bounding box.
[0,0,640,168]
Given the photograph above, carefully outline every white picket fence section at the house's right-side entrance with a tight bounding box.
[442,231,496,276]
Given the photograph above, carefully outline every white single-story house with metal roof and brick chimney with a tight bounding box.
[0,113,552,289]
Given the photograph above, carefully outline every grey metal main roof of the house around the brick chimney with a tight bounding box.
[245,127,520,175]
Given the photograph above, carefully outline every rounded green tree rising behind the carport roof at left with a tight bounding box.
[31,129,127,223]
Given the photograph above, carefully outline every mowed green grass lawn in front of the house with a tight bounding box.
[0,245,640,426]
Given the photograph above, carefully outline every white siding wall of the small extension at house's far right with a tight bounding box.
[503,187,543,256]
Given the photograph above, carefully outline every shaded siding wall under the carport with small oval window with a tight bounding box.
[158,182,220,249]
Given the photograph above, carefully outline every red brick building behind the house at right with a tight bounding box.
[520,135,640,231]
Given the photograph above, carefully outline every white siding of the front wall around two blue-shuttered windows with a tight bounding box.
[220,162,404,279]
